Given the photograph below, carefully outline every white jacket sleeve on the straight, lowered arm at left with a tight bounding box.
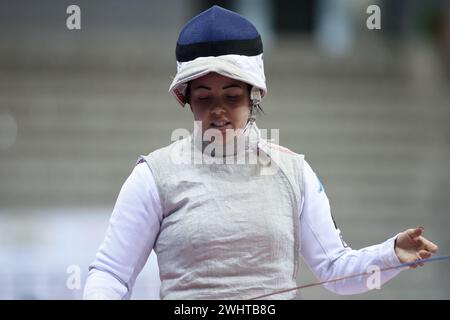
[83,162,162,299]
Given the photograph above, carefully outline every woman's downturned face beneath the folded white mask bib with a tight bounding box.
[190,73,250,142]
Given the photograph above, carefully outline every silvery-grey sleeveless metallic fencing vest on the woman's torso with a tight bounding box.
[142,124,303,299]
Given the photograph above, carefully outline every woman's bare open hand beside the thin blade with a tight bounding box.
[395,227,438,268]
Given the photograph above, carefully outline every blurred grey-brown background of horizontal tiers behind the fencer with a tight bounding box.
[0,0,450,299]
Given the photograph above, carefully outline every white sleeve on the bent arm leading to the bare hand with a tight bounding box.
[299,161,401,294]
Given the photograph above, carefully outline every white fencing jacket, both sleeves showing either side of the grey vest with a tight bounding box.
[84,161,403,299]
